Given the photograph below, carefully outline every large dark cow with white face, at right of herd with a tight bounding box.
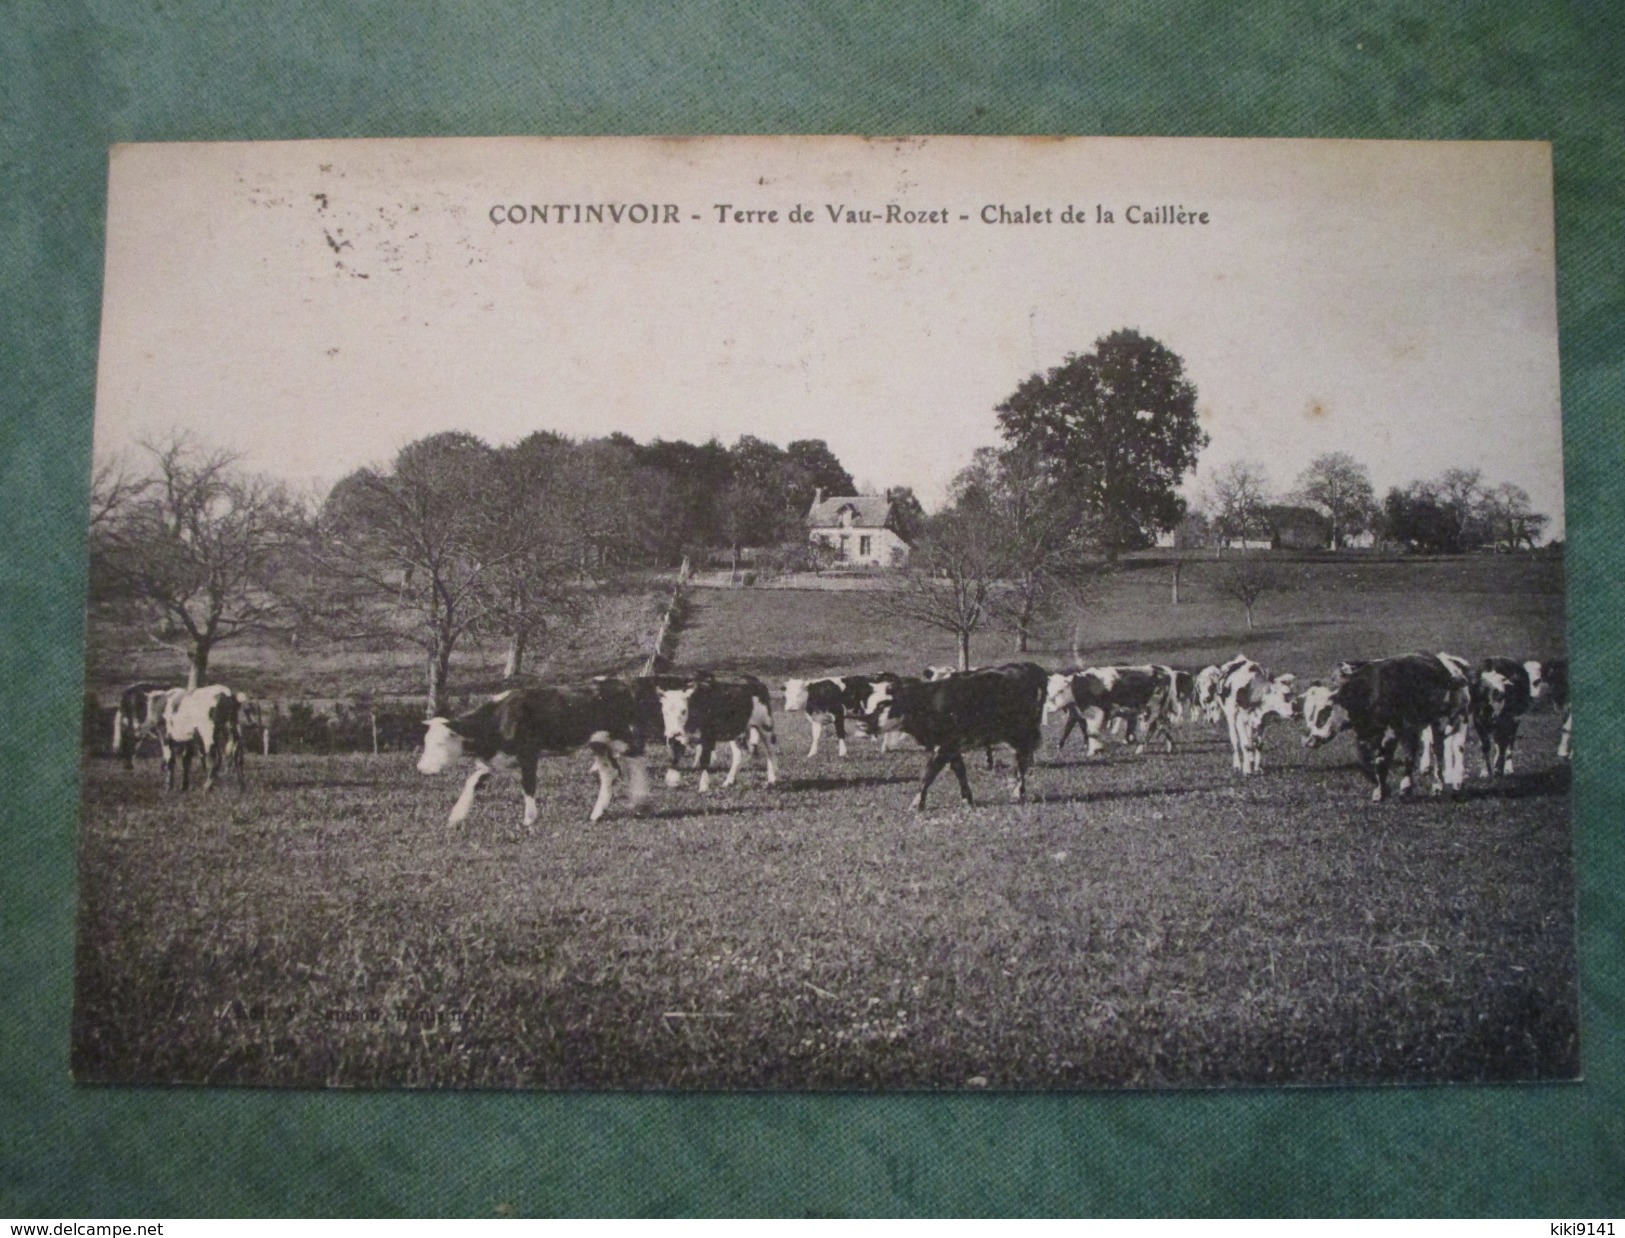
[1305,653,1472,801]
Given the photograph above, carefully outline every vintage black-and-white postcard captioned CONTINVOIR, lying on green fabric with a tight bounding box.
[72,136,1584,1090]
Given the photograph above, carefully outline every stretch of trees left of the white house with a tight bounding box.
[91,431,877,710]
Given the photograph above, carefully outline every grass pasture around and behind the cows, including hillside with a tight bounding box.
[73,561,1583,1089]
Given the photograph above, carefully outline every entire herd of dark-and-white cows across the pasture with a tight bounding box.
[104,640,1573,825]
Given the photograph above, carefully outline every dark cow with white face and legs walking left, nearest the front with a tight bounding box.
[418,679,648,825]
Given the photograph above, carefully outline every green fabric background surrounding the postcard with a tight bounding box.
[0,0,1625,1220]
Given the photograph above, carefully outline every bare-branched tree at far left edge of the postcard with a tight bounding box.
[91,435,297,687]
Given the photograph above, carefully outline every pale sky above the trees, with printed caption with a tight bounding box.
[96,138,1563,536]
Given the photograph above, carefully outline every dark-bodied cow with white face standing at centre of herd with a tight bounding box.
[865,661,1048,811]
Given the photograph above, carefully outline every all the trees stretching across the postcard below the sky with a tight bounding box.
[91,328,1549,712]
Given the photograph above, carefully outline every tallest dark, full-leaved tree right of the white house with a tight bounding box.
[998,330,1207,559]
